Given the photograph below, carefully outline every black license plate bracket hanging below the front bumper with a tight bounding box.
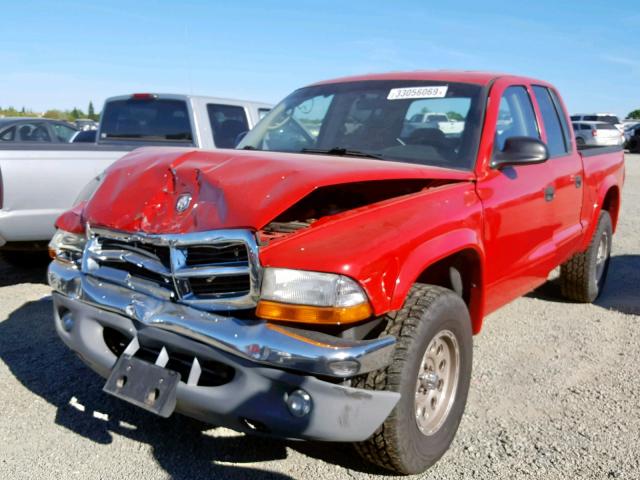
[102,355,180,418]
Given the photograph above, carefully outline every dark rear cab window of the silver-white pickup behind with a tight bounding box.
[100,98,193,143]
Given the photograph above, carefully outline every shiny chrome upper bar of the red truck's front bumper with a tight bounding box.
[48,261,396,378]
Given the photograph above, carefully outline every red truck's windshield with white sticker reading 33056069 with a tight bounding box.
[238,80,484,169]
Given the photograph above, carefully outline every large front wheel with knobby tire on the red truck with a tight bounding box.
[354,285,473,474]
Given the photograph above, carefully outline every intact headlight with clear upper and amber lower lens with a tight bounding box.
[256,268,372,324]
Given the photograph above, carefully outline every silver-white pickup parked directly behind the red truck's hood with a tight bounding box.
[0,93,271,265]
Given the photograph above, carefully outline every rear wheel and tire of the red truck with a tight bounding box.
[560,210,612,303]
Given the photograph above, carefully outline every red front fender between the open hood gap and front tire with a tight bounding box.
[260,181,482,315]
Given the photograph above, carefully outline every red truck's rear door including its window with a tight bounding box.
[533,85,584,263]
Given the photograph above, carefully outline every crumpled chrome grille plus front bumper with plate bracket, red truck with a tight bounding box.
[48,223,398,441]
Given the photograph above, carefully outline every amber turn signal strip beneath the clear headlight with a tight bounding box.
[256,300,373,325]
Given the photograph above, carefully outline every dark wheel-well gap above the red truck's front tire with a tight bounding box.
[416,249,482,333]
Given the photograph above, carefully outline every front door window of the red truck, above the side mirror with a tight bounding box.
[495,86,540,150]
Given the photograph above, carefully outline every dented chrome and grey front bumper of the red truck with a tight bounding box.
[48,262,400,442]
